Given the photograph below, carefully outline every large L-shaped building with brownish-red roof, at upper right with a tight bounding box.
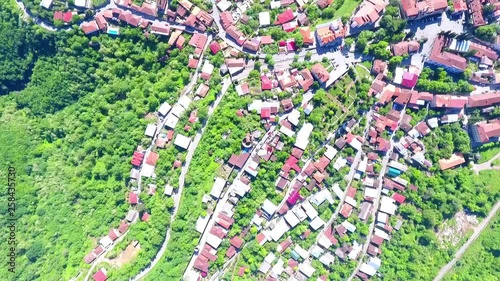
[427,36,467,73]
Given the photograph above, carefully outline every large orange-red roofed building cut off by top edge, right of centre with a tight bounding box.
[401,0,448,20]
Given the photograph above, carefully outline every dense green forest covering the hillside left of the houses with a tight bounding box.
[0,1,192,280]
